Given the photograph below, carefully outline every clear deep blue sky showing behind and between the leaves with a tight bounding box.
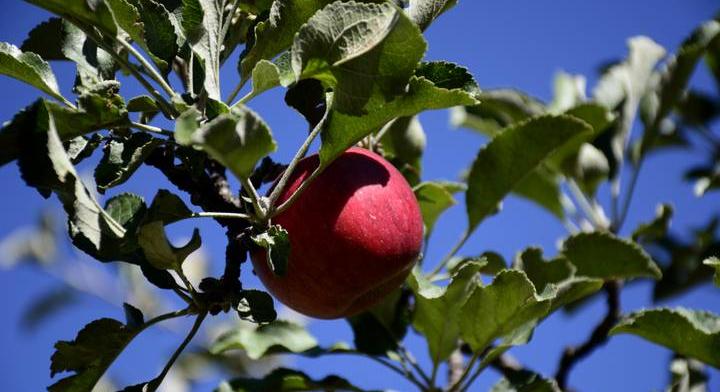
[0,0,720,391]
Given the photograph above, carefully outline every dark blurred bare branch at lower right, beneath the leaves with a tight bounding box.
[555,280,620,390]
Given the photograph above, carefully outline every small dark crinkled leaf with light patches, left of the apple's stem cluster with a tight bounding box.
[95,132,162,193]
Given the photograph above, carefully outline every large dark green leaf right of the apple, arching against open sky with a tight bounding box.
[465,116,592,230]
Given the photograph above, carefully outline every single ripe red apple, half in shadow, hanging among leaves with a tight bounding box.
[250,147,423,319]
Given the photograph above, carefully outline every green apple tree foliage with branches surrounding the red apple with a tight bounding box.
[0,0,720,392]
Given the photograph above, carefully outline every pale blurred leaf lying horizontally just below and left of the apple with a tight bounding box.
[210,320,317,360]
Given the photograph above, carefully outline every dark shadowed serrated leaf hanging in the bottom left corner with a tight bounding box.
[48,318,140,392]
